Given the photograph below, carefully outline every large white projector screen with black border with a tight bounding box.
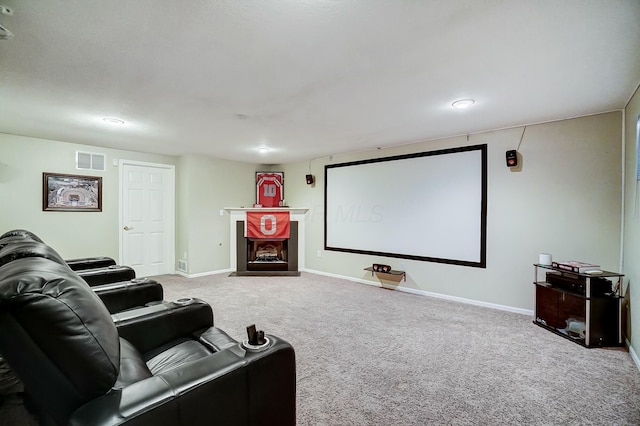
[324,144,487,268]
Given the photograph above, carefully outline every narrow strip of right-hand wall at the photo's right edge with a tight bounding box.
[623,85,640,354]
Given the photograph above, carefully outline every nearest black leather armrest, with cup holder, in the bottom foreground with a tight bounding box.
[69,336,296,426]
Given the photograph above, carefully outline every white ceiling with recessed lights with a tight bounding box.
[0,0,640,164]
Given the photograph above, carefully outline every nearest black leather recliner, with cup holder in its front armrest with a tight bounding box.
[0,257,295,426]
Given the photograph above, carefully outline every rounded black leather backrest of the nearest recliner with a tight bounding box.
[0,257,120,402]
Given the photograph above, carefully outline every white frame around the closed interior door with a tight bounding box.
[118,159,176,274]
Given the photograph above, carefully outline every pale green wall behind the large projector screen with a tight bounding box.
[283,112,621,310]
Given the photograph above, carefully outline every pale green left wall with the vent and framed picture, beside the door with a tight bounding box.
[0,133,177,259]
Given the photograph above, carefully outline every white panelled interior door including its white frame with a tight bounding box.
[120,160,175,277]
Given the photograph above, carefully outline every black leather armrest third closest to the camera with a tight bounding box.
[91,278,164,314]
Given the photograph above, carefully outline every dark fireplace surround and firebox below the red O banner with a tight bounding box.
[236,221,300,276]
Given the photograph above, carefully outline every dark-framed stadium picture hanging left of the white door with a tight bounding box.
[42,172,102,212]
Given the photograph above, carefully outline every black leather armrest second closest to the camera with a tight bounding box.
[111,299,213,353]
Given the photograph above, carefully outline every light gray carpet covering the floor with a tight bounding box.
[156,273,640,425]
